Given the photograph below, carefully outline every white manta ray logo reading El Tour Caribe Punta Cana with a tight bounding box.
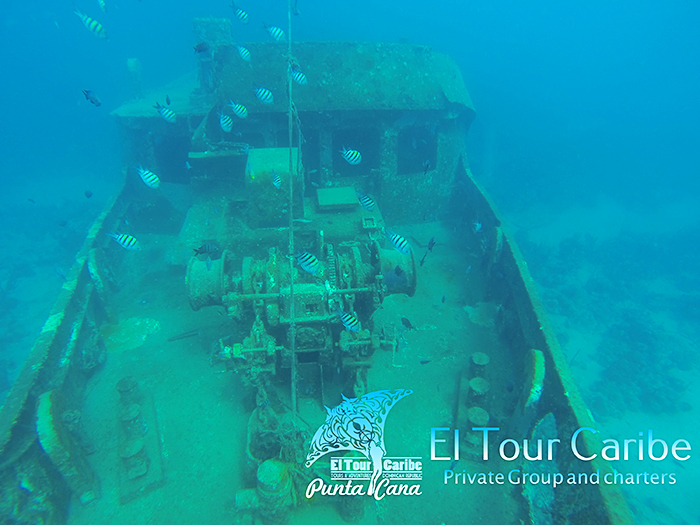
[306,389,422,497]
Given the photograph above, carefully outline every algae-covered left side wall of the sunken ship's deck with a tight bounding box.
[0,179,127,524]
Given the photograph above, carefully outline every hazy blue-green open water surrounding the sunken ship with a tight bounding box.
[0,0,700,523]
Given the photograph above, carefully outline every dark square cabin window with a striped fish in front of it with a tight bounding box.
[333,129,380,177]
